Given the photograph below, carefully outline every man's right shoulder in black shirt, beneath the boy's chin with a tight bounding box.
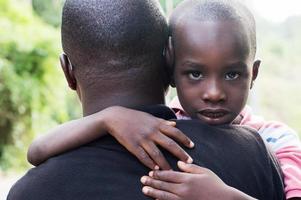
[173,120,283,199]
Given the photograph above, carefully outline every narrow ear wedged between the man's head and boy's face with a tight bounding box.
[165,36,175,87]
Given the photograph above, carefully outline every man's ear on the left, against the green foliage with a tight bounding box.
[60,53,77,90]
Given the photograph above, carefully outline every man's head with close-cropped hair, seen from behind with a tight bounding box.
[61,0,168,114]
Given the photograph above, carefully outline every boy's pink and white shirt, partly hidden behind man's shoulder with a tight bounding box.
[169,98,301,199]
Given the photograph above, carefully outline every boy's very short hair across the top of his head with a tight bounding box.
[169,0,256,56]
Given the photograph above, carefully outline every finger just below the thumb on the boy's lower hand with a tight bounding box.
[149,170,187,183]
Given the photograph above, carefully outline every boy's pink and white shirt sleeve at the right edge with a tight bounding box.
[255,121,301,199]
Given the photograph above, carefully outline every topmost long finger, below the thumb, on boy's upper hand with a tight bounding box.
[159,121,194,148]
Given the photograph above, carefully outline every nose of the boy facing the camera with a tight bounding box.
[202,81,226,103]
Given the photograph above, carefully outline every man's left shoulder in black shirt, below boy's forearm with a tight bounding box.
[8,145,148,200]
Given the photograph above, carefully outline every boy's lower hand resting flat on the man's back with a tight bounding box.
[141,161,252,200]
